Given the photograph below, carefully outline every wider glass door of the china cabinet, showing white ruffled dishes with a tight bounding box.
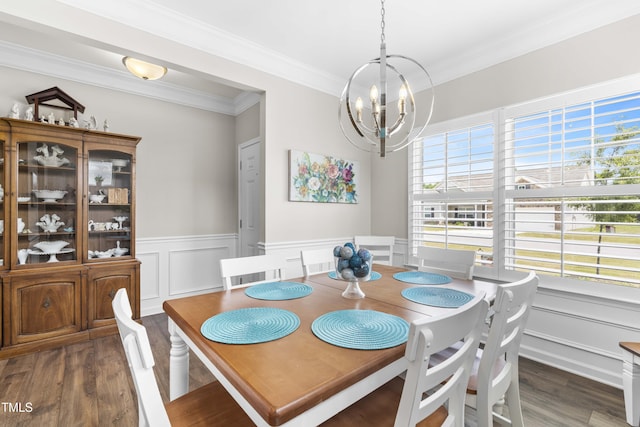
[13,141,79,265]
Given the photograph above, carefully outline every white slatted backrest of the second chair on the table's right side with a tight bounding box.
[477,271,538,409]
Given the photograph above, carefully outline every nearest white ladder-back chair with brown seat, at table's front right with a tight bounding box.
[322,293,489,427]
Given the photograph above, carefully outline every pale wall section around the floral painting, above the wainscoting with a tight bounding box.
[265,81,371,243]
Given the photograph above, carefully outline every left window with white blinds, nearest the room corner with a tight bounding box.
[409,116,495,262]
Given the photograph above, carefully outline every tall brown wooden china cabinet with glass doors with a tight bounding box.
[0,118,140,359]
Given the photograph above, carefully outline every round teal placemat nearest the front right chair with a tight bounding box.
[311,310,409,350]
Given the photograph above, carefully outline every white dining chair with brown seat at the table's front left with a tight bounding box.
[111,288,254,427]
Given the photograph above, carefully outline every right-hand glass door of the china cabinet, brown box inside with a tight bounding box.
[86,150,133,260]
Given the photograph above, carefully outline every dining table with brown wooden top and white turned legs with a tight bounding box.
[163,264,496,426]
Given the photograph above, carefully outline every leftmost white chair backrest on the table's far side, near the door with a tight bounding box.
[220,254,285,290]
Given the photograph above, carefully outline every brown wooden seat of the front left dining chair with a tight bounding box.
[165,381,255,427]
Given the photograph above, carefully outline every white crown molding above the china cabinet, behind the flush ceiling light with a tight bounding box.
[0,41,254,116]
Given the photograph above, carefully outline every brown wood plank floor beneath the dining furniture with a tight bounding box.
[0,314,628,427]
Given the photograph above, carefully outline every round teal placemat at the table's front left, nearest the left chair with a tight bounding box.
[200,307,300,344]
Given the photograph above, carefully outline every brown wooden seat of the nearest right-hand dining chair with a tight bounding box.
[321,377,448,427]
